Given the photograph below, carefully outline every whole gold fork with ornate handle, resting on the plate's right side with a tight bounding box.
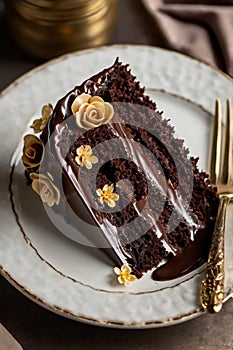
[200,99,233,313]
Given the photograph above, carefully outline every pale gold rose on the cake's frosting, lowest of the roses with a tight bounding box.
[30,173,60,207]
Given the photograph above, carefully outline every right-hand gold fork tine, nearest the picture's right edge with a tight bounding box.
[222,99,233,184]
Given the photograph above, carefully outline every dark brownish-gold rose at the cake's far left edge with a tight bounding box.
[22,134,44,168]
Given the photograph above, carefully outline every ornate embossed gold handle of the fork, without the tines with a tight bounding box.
[200,194,232,313]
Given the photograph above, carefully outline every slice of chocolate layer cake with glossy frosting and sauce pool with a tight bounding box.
[22,59,218,285]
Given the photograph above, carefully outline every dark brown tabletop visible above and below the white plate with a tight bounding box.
[0,0,233,350]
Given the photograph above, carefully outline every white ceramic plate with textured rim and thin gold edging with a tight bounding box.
[0,45,233,328]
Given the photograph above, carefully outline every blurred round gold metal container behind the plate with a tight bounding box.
[5,0,118,59]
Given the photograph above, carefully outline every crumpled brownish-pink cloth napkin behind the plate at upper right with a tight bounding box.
[142,0,233,76]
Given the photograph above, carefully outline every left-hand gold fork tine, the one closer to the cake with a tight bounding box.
[210,99,222,185]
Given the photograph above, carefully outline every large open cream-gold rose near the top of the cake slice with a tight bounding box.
[71,93,114,130]
